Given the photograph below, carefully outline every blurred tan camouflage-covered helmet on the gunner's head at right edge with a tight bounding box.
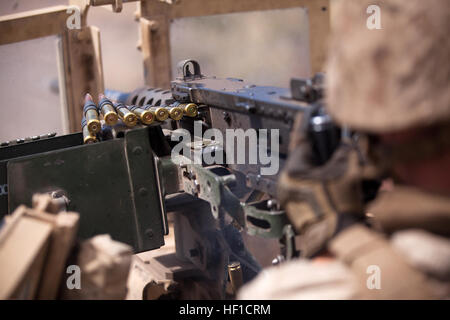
[327,0,450,133]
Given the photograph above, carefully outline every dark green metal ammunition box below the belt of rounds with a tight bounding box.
[7,128,164,251]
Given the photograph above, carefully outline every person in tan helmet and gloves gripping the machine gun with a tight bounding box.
[239,0,450,299]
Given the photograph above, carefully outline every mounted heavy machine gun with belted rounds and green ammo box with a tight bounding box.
[0,60,340,296]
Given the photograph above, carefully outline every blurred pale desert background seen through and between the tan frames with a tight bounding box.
[0,0,310,141]
